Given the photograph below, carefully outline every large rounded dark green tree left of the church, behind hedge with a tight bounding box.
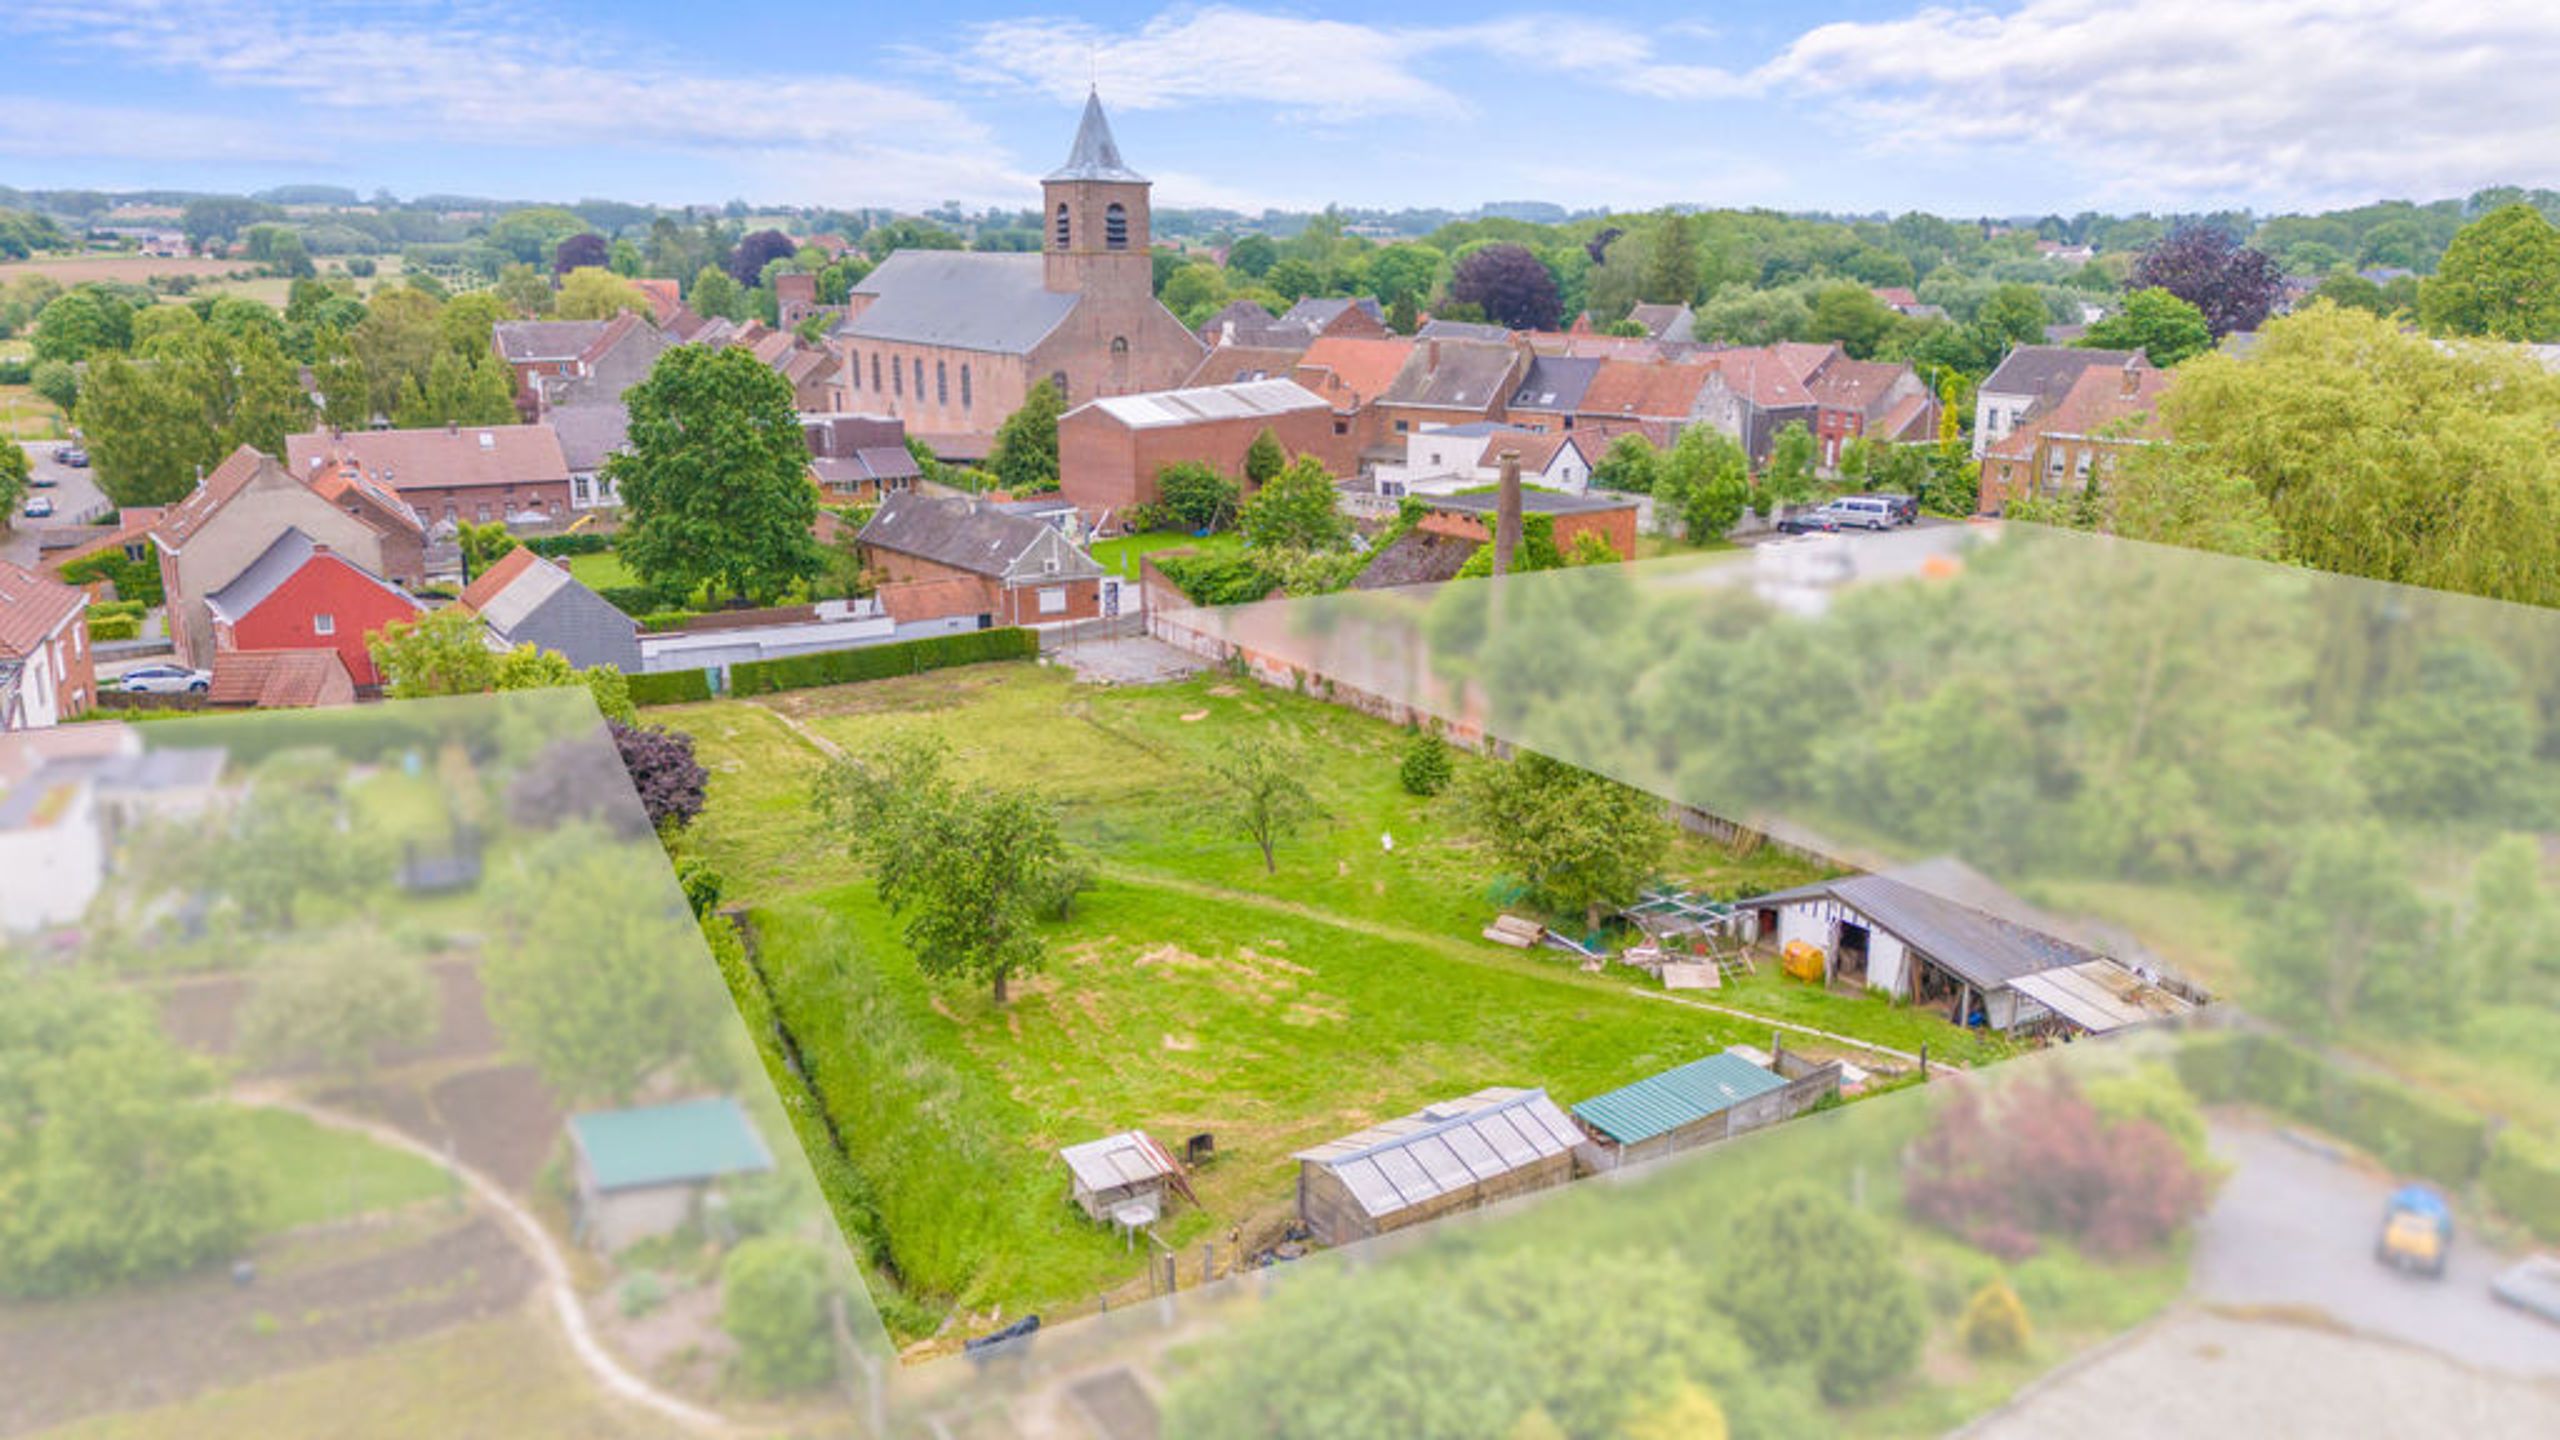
[607,346,827,600]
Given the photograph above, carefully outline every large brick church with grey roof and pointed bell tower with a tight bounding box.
[829,95,1206,461]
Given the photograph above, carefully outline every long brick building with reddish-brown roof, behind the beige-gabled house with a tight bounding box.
[284,425,573,530]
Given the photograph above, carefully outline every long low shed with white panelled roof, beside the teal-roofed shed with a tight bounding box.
[1295,1086,1582,1245]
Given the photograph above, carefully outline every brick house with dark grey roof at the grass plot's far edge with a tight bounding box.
[855,492,1103,630]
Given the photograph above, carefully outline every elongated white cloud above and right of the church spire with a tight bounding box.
[952,5,1741,120]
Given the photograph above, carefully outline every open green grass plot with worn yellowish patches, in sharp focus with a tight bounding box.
[650,664,1997,1332]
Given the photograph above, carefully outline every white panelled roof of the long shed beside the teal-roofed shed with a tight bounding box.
[1293,1086,1580,1217]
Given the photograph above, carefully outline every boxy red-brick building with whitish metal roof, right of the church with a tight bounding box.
[1057,379,1357,520]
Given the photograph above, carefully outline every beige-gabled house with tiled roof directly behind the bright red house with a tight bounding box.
[151,446,425,666]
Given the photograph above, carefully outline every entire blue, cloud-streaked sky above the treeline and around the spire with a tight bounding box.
[0,0,2560,215]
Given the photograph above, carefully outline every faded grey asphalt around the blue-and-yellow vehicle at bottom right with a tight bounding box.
[2194,1122,2560,1379]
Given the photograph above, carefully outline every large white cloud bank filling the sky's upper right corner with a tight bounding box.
[1751,0,2560,205]
